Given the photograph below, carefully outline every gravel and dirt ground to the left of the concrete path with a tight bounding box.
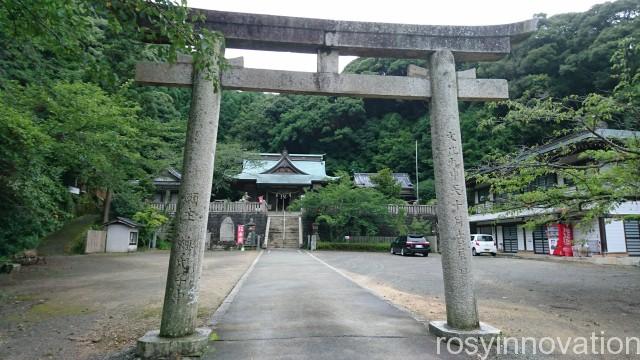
[0,251,257,360]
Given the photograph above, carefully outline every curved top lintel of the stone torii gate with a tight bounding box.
[198,9,538,61]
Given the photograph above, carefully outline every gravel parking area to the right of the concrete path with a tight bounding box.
[314,251,640,358]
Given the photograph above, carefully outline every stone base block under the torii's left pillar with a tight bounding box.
[136,328,211,359]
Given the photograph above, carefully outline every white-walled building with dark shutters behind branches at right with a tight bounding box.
[467,129,640,256]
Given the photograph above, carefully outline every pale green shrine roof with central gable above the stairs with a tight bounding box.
[234,151,334,185]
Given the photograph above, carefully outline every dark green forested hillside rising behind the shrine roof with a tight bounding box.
[220,0,640,199]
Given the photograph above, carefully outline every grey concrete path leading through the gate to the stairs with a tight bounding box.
[205,250,462,360]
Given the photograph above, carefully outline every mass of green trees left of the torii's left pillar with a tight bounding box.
[0,0,225,256]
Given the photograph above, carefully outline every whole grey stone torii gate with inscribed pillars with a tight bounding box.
[136,10,536,358]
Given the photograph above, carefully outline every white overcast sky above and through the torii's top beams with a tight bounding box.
[188,0,605,71]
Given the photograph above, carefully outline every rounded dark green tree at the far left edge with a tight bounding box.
[0,96,69,257]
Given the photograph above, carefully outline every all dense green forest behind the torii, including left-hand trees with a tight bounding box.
[0,0,640,256]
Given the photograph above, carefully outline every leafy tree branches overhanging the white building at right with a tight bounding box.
[476,39,640,228]
